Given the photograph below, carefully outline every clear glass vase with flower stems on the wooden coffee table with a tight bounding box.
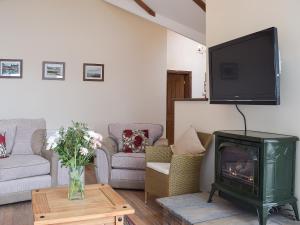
[68,166,85,200]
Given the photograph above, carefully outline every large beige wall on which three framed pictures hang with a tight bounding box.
[0,0,166,134]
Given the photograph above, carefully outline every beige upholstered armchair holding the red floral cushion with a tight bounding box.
[95,123,168,189]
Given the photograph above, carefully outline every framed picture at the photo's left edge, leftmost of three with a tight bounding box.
[0,59,23,78]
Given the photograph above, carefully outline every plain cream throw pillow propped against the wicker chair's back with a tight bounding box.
[171,127,206,155]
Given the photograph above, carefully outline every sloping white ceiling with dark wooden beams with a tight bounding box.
[104,0,205,44]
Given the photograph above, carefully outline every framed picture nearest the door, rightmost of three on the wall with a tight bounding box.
[83,63,104,81]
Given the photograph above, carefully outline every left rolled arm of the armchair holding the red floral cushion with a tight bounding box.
[94,137,118,184]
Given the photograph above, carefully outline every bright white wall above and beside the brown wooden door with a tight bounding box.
[167,30,206,98]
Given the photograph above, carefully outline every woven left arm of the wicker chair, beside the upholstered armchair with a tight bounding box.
[146,146,173,163]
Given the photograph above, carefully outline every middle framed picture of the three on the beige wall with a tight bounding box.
[43,62,65,80]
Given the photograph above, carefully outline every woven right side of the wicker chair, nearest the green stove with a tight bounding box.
[169,154,204,195]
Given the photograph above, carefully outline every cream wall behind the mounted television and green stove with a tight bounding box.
[175,0,300,207]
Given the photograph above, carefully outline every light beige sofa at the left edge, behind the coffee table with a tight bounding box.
[0,119,68,205]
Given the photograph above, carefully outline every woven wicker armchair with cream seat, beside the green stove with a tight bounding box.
[145,132,212,203]
